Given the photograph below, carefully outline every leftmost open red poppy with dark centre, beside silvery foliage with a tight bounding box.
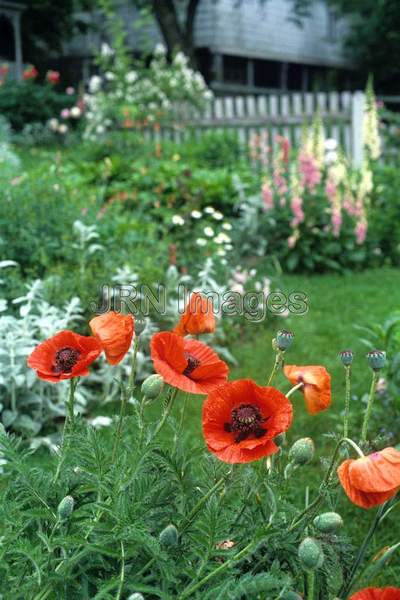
[27,329,102,383]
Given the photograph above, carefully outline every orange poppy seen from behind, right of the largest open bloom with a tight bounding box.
[283,365,331,415]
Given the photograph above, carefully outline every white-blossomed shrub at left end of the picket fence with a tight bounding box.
[84,44,211,140]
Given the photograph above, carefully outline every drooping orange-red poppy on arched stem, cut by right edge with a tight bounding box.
[337,448,400,508]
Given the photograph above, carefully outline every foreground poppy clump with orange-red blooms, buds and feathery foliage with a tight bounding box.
[0,303,400,600]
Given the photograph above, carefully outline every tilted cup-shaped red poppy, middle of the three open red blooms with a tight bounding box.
[151,331,229,394]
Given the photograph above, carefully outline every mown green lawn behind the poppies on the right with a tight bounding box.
[168,267,400,585]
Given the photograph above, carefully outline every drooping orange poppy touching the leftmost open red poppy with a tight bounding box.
[89,310,135,365]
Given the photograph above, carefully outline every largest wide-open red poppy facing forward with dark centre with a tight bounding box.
[203,379,293,463]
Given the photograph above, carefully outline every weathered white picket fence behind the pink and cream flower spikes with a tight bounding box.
[146,92,365,165]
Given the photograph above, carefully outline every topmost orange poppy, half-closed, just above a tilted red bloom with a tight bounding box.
[173,292,215,335]
